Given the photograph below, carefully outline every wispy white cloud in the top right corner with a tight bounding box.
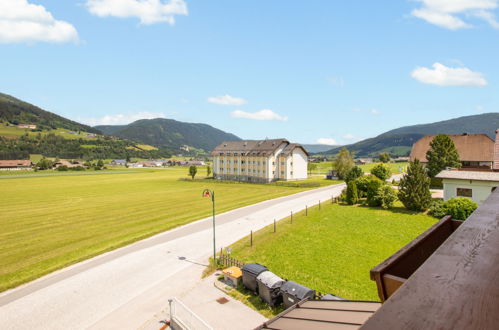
[412,0,499,30]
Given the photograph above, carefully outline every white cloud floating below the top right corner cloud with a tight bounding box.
[411,63,487,86]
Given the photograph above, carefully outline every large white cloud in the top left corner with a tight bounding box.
[0,0,78,43]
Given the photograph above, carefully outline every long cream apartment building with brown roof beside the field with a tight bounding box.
[211,139,308,182]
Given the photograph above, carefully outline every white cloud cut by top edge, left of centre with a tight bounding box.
[86,0,188,25]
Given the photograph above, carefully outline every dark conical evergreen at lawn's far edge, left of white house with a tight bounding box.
[398,159,431,211]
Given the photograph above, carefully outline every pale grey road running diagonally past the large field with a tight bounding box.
[0,184,345,329]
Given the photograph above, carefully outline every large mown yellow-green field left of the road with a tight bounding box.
[0,168,338,291]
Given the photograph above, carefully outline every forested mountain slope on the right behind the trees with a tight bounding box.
[323,112,499,157]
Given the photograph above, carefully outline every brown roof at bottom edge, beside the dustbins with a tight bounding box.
[256,300,381,330]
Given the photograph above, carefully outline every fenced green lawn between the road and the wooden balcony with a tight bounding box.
[232,204,437,301]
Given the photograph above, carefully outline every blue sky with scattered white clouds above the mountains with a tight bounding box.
[0,0,499,144]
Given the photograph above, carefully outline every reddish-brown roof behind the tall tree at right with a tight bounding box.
[411,134,494,163]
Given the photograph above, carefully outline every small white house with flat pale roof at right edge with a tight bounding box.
[436,170,499,204]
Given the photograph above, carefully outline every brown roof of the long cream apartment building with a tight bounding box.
[211,139,289,155]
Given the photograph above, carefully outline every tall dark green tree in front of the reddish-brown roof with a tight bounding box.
[426,134,461,178]
